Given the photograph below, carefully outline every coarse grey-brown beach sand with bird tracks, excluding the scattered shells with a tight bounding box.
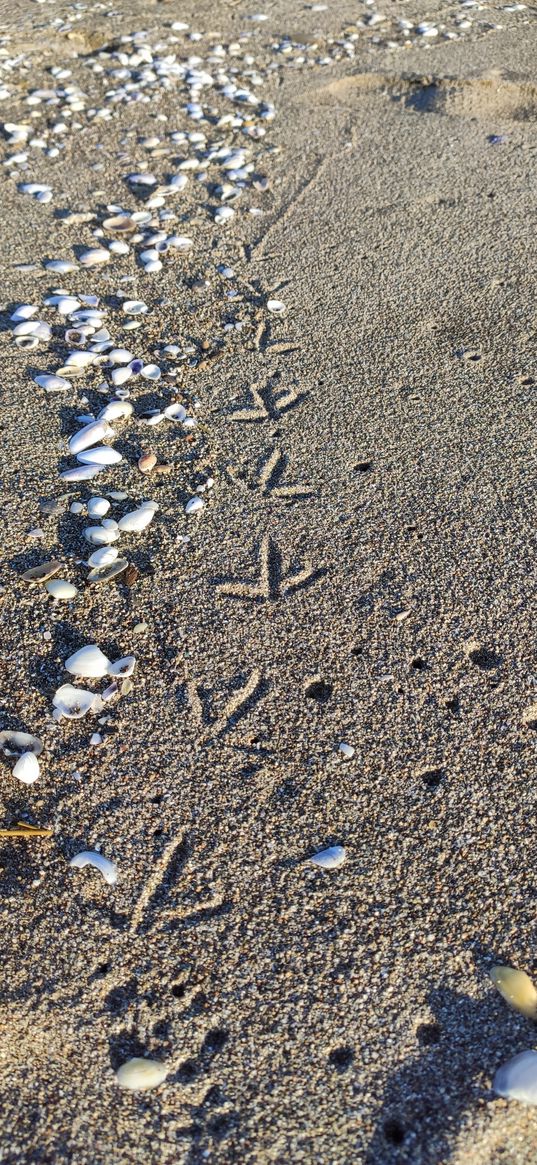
[0,0,537,1165]
